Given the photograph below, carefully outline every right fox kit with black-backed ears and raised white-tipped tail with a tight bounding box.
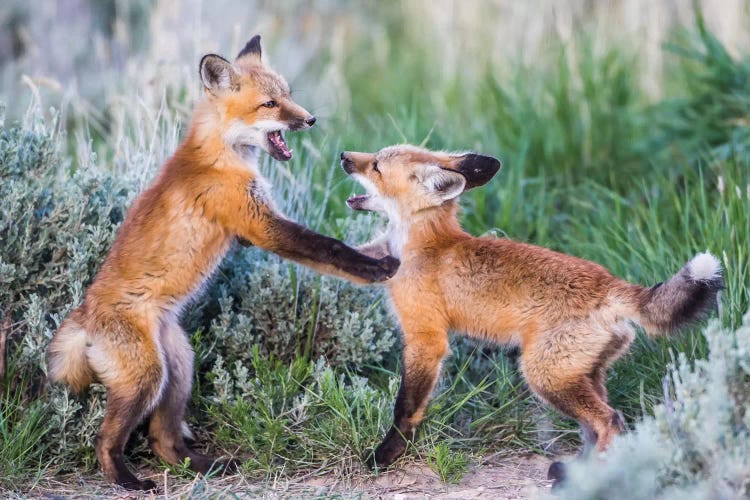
[341,146,722,476]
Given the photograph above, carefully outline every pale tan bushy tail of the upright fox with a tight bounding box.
[47,318,94,392]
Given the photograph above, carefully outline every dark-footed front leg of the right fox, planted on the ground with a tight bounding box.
[367,325,448,467]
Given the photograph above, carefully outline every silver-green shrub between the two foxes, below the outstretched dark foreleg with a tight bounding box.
[200,250,396,365]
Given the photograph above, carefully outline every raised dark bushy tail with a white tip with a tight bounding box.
[638,252,723,335]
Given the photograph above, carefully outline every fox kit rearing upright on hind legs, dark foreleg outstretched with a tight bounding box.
[48,36,398,489]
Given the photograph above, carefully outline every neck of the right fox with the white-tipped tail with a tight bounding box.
[388,203,469,259]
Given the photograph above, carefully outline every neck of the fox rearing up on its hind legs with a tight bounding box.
[180,101,260,175]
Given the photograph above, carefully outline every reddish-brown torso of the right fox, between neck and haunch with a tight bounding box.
[391,237,627,344]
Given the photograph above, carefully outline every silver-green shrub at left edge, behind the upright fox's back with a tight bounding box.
[0,108,134,469]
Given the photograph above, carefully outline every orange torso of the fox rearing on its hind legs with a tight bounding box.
[86,163,232,316]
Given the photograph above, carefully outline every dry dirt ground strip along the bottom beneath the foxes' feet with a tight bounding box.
[17,455,550,500]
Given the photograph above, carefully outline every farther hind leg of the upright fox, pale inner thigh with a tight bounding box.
[149,318,236,474]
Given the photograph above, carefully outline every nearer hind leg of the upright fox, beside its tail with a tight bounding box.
[87,321,166,490]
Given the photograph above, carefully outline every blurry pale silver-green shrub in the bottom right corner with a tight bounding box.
[555,311,750,500]
